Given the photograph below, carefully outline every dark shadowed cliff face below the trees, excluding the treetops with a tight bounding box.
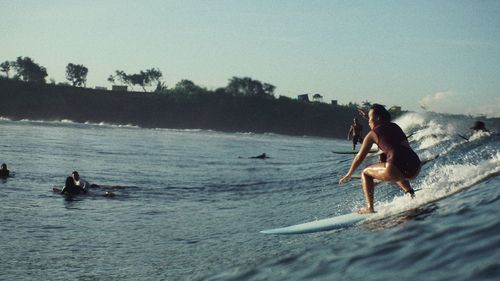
[0,79,367,138]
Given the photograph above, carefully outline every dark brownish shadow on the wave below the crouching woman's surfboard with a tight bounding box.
[363,203,438,230]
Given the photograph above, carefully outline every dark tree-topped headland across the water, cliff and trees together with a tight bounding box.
[0,57,410,137]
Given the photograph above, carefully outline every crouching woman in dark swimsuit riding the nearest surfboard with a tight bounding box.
[339,104,421,214]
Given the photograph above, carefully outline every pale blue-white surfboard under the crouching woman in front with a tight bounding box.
[261,213,371,234]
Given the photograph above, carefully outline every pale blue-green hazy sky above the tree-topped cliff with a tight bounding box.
[0,0,500,117]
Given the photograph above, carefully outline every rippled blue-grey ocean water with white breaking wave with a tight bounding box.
[0,113,500,281]
